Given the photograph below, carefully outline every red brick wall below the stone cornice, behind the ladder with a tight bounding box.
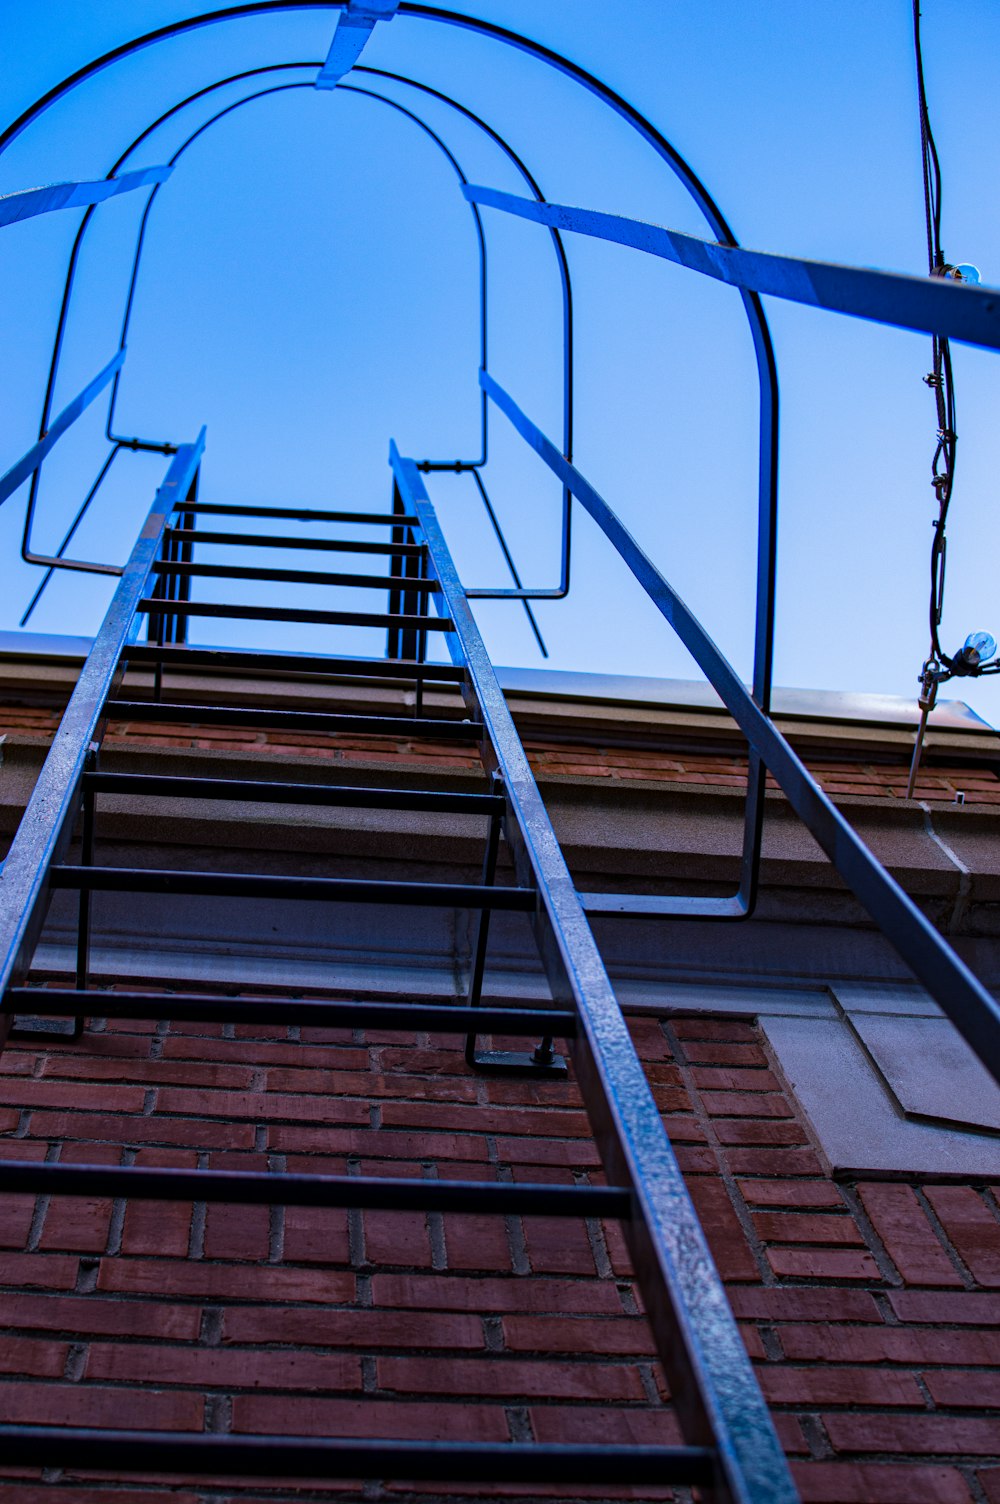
[0,992,1000,1504]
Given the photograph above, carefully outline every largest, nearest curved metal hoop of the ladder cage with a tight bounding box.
[0,0,779,919]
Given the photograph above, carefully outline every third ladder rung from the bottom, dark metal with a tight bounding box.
[3,987,576,1039]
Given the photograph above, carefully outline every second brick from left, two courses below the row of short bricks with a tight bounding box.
[223,1305,484,1352]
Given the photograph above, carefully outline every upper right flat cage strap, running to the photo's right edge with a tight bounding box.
[463,185,1000,350]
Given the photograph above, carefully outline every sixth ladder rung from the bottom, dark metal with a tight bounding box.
[104,699,483,741]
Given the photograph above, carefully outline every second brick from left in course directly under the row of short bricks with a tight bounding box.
[98,1259,355,1304]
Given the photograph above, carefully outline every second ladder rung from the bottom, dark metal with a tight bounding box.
[0,1160,632,1221]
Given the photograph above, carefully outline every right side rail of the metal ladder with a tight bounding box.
[389,444,797,1504]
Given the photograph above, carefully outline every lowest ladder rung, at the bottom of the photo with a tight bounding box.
[0,1425,716,1486]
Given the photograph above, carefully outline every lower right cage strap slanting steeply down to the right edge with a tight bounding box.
[475,376,1000,1080]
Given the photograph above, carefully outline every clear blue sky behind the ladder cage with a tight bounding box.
[0,0,1000,722]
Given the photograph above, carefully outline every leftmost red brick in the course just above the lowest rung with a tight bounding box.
[3,1384,205,1430]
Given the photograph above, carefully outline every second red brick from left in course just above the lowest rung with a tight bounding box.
[233,1394,510,1441]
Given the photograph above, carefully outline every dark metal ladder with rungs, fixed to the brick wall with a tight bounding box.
[0,433,795,1504]
